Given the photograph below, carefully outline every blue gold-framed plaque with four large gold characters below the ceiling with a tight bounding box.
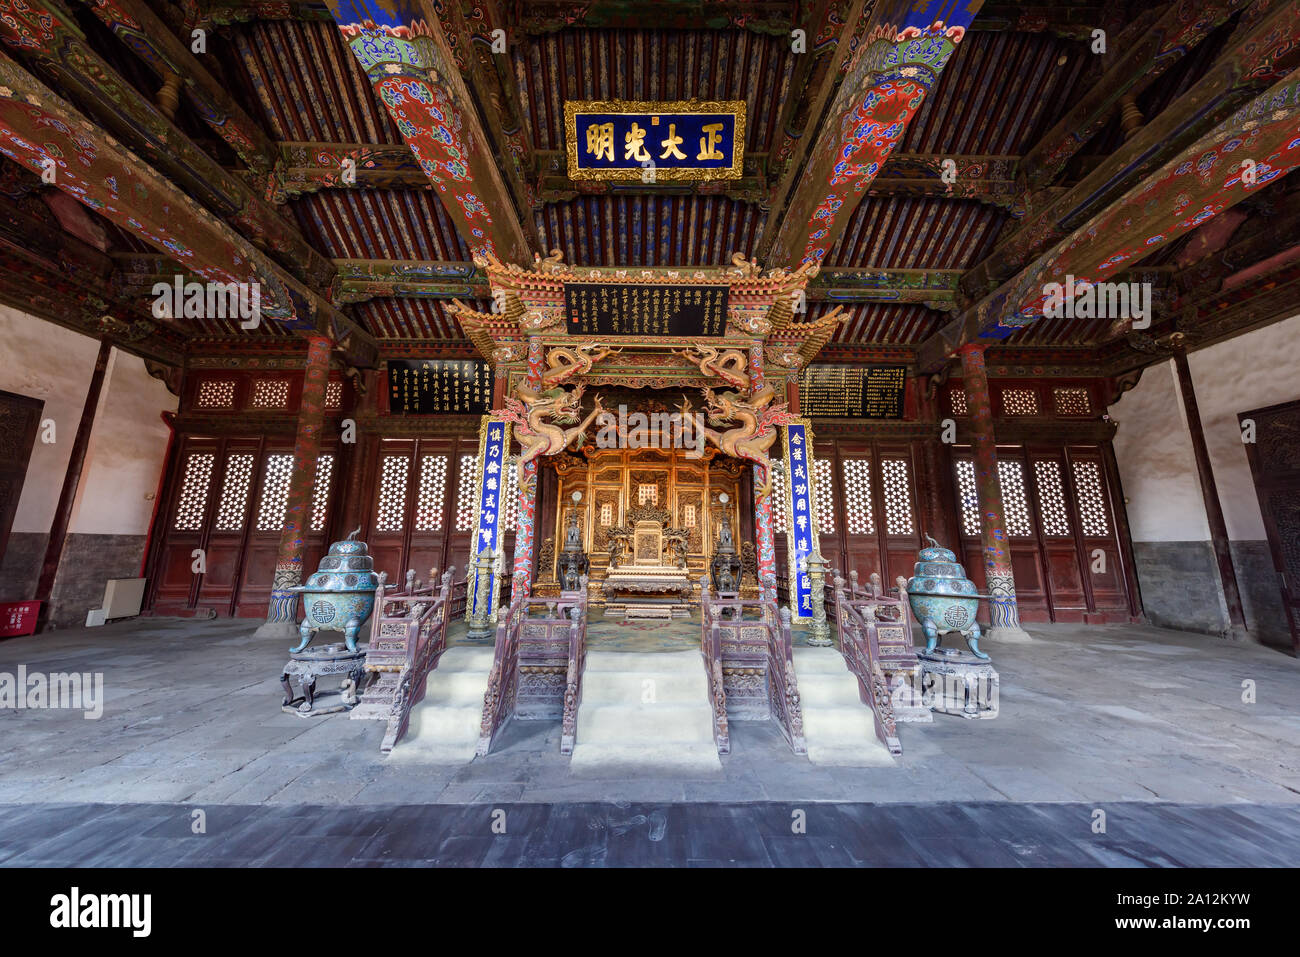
[564,100,745,183]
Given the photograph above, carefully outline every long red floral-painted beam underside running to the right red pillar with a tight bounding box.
[918,70,1300,372]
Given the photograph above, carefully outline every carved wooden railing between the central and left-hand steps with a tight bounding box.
[477,581,588,754]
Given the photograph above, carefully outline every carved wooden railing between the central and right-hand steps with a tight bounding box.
[701,583,807,754]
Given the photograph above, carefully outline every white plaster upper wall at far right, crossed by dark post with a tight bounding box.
[1109,316,1300,542]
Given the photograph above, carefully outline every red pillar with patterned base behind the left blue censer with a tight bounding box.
[257,335,330,638]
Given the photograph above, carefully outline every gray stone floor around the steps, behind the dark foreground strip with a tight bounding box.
[0,619,1300,806]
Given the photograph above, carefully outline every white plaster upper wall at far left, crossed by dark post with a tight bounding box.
[0,304,177,534]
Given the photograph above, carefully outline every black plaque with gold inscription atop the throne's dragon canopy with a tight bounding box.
[564,282,728,335]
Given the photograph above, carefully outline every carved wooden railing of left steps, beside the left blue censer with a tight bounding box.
[352,568,455,753]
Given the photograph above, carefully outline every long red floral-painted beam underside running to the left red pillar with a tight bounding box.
[0,53,374,365]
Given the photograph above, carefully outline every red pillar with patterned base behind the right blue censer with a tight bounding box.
[962,343,1031,641]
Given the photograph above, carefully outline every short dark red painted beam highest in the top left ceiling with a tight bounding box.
[82,0,276,173]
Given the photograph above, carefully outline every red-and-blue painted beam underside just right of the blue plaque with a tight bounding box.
[759,0,983,265]
